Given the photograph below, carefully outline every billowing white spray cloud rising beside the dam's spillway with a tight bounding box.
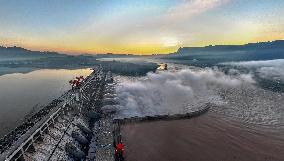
[117,68,253,117]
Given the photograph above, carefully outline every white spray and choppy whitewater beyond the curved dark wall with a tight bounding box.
[116,65,284,127]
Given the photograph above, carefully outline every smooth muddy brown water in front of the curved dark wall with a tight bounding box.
[121,112,284,161]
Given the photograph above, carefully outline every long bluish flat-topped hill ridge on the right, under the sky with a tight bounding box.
[161,40,284,66]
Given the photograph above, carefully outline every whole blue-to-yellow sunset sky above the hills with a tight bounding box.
[0,0,284,54]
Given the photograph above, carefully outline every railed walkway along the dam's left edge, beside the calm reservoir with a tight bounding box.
[0,68,103,161]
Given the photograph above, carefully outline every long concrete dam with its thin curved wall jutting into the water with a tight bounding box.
[0,66,210,161]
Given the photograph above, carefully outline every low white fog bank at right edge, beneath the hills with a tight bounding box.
[222,59,284,83]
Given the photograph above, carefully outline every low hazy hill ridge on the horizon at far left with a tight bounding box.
[0,46,66,60]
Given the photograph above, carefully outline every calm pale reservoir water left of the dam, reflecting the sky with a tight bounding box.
[0,69,91,136]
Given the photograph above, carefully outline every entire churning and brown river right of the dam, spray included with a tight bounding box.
[116,64,284,161]
